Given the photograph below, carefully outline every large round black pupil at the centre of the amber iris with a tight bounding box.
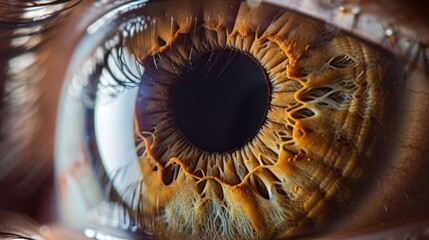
[173,49,270,152]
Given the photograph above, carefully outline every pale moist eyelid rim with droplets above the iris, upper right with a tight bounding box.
[263,0,429,69]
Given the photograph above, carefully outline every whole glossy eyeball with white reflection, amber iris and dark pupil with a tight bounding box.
[2,1,427,239]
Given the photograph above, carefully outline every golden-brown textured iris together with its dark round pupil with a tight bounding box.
[126,1,398,239]
